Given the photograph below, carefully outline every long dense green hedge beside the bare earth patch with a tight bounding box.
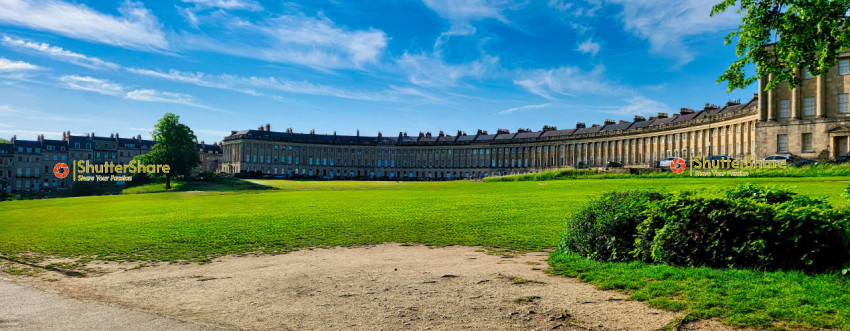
[561,184,850,271]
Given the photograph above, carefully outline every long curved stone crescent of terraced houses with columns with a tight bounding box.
[221,62,850,180]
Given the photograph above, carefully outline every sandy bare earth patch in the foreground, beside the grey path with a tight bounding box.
[6,244,736,330]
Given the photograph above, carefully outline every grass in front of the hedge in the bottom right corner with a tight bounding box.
[550,251,850,330]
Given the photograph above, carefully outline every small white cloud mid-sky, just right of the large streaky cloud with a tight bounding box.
[398,53,499,87]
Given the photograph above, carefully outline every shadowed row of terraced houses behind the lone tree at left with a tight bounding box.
[0,132,222,192]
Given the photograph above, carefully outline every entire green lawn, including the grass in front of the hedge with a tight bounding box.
[0,177,850,329]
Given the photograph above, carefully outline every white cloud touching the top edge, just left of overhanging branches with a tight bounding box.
[609,0,740,66]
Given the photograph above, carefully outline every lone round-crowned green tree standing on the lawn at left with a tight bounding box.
[136,113,201,189]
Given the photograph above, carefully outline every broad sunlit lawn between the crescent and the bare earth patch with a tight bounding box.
[0,178,850,261]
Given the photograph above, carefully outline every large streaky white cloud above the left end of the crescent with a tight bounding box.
[180,13,388,69]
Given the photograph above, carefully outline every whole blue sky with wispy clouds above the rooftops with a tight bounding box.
[0,0,756,142]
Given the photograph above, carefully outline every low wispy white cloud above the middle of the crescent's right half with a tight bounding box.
[514,65,628,99]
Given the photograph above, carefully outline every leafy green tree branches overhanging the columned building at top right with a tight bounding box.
[711,0,850,92]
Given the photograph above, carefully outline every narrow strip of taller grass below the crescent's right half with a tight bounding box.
[484,164,850,182]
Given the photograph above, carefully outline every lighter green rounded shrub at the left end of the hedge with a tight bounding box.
[561,191,662,261]
